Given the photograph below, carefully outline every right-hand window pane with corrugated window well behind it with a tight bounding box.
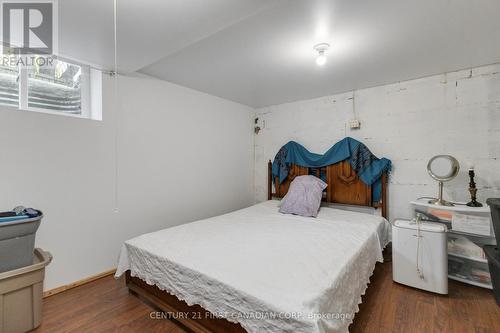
[28,60,82,114]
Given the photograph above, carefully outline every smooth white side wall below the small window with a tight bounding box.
[0,77,254,290]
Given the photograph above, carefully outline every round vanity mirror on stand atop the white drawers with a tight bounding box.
[427,155,460,206]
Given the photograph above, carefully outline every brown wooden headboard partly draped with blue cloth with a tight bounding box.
[267,161,387,218]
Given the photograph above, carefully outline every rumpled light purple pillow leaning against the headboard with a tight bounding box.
[280,175,327,217]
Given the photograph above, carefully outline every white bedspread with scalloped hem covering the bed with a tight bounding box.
[116,201,389,333]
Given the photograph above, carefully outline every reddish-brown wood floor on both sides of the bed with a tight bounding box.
[35,262,500,333]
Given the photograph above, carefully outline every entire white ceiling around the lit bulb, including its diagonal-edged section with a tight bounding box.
[56,0,500,107]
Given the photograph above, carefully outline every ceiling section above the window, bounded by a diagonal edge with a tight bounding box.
[58,0,284,72]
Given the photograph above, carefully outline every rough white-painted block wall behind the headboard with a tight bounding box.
[255,65,500,222]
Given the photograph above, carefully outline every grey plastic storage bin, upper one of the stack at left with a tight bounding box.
[0,212,43,273]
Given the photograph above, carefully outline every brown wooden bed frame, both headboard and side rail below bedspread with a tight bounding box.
[125,161,387,333]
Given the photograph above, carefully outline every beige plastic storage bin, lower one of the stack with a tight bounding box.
[0,249,52,333]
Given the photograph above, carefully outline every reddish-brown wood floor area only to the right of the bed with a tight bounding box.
[349,262,500,333]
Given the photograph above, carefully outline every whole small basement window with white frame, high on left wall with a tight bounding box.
[0,58,102,120]
